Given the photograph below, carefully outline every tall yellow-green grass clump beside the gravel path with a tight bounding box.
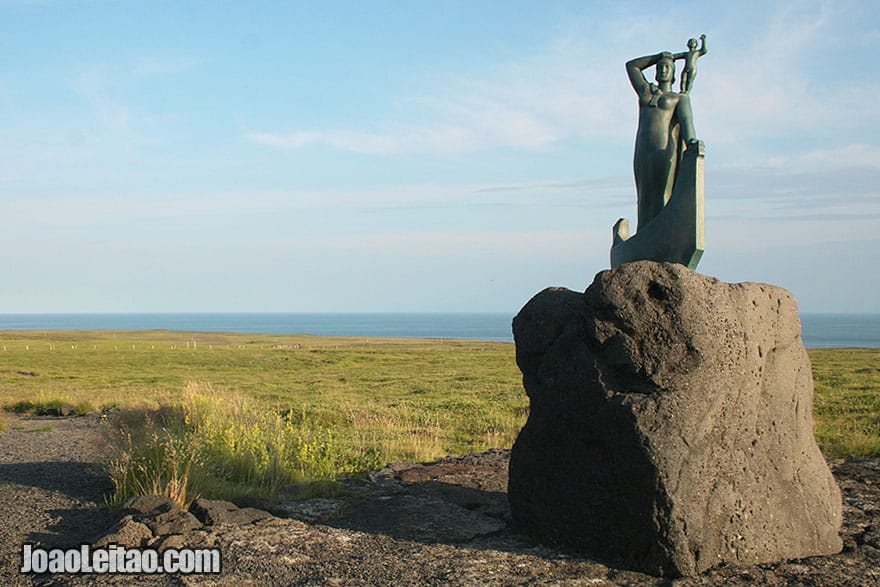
[109,383,381,505]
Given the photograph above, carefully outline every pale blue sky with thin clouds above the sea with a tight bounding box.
[0,0,880,313]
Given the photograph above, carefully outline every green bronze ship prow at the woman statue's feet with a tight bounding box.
[611,142,705,269]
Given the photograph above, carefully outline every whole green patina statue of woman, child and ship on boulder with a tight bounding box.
[611,35,706,269]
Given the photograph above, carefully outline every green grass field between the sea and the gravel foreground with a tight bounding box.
[0,331,880,500]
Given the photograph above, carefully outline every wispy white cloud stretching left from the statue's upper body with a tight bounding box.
[245,29,631,156]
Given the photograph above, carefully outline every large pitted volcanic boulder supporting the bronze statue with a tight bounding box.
[508,261,842,576]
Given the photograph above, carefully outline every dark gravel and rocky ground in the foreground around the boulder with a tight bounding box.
[0,416,880,587]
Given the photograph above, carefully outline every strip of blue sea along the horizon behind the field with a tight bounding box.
[0,312,880,348]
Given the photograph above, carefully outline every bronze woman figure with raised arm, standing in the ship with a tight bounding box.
[626,52,698,230]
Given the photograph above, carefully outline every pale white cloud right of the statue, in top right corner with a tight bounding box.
[694,2,880,152]
